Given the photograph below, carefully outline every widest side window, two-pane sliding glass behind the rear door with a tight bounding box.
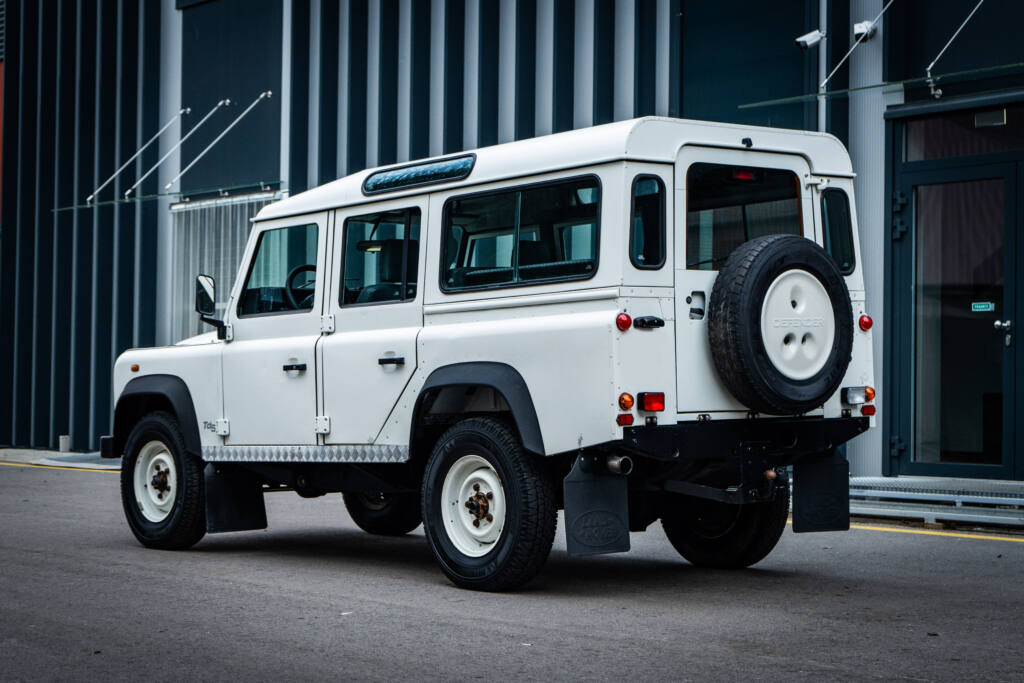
[441,177,600,292]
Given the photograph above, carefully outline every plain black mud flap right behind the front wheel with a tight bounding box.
[203,463,266,533]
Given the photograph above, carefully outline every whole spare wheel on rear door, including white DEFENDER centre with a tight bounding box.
[708,234,853,415]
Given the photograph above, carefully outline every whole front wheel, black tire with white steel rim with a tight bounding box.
[121,412,206,550]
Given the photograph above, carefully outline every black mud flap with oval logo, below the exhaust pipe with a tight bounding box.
[562,456,630,555]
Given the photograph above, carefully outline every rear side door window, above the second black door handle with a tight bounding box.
[340,209,420,306]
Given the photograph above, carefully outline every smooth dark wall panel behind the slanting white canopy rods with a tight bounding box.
[181,0,282,194]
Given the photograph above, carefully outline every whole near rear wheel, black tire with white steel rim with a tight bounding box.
[421,418,557,591]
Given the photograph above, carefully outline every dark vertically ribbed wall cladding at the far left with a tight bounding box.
[0,0,160,450]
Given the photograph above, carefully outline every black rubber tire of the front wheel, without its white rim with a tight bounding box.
[121,413,206,550]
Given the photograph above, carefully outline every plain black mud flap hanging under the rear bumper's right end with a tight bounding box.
[793,453,850,533]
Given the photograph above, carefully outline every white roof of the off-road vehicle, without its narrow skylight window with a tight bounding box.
[255,117,853,220]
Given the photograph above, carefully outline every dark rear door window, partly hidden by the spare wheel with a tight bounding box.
[686,164,803,270]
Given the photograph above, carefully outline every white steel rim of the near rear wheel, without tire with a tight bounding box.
[441,455,506,557]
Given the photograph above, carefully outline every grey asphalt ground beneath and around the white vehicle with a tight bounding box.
[0,464,1024,681]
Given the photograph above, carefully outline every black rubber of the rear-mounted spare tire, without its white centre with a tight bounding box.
[708,234,853,415]
